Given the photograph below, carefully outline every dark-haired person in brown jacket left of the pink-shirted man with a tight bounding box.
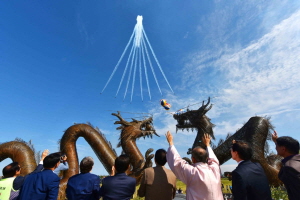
[138,149,176,200]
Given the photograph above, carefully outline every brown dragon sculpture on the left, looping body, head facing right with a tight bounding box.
[0,112,158,199]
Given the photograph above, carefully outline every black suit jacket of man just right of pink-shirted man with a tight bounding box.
[232,160,272,200]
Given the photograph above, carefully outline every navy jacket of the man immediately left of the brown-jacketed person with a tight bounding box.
[101,173,136,200]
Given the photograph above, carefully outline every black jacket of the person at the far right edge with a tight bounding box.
[278,154,300,200]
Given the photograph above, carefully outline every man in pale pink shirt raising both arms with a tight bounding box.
[166,131,223,200]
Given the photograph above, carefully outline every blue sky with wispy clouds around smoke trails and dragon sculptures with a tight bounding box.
[0,0,300,174]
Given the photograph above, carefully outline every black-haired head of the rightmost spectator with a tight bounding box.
[276,136,299,157]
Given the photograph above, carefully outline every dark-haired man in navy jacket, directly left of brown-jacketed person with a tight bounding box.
[101,155,136,200]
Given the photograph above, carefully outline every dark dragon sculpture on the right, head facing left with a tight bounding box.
[173,98,280,186]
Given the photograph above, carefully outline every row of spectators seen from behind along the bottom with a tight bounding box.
[0,131,300,200]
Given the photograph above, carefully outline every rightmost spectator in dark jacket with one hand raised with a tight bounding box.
[272,131,300,200]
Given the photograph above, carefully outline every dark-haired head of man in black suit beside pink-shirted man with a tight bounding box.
[231,140,253,162]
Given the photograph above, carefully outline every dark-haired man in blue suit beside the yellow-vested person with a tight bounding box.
[19,153,60,200]
